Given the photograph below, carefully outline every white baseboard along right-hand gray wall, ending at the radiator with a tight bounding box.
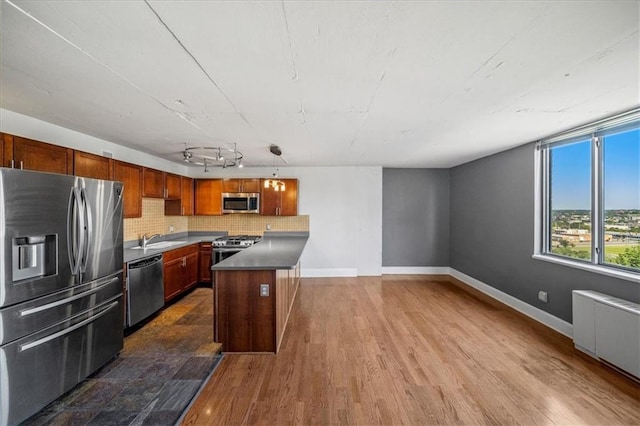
[449,268,573,339]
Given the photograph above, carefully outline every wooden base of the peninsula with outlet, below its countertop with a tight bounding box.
[214,269,299,353]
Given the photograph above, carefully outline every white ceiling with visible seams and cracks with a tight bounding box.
[0,0,640,167]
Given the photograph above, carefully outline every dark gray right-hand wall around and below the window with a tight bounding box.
[450,144,640,322]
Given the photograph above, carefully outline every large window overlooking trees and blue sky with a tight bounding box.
[539,109,640,274]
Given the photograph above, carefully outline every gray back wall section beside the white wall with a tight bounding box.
[382,169,449,266]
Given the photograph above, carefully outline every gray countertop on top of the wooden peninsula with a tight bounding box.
[211,233,309,271]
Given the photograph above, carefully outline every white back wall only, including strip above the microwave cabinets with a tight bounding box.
[192,166,382,277]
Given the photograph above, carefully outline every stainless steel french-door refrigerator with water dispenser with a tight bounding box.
[0,169,123,424]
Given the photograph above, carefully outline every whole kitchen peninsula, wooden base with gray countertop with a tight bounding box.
[211,232,309,353]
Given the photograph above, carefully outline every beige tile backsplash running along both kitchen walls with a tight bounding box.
[124,198,309,241]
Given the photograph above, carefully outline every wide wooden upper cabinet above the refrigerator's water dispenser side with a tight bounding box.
[10,136,73,175]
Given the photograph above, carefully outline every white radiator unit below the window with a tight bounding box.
[573,290,640,378]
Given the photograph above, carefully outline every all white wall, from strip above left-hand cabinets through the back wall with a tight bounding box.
[0,109,382,277]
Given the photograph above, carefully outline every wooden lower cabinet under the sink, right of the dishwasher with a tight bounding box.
[162,244,199,302]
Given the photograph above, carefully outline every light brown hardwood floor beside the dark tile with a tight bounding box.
[183,275,640,425]
